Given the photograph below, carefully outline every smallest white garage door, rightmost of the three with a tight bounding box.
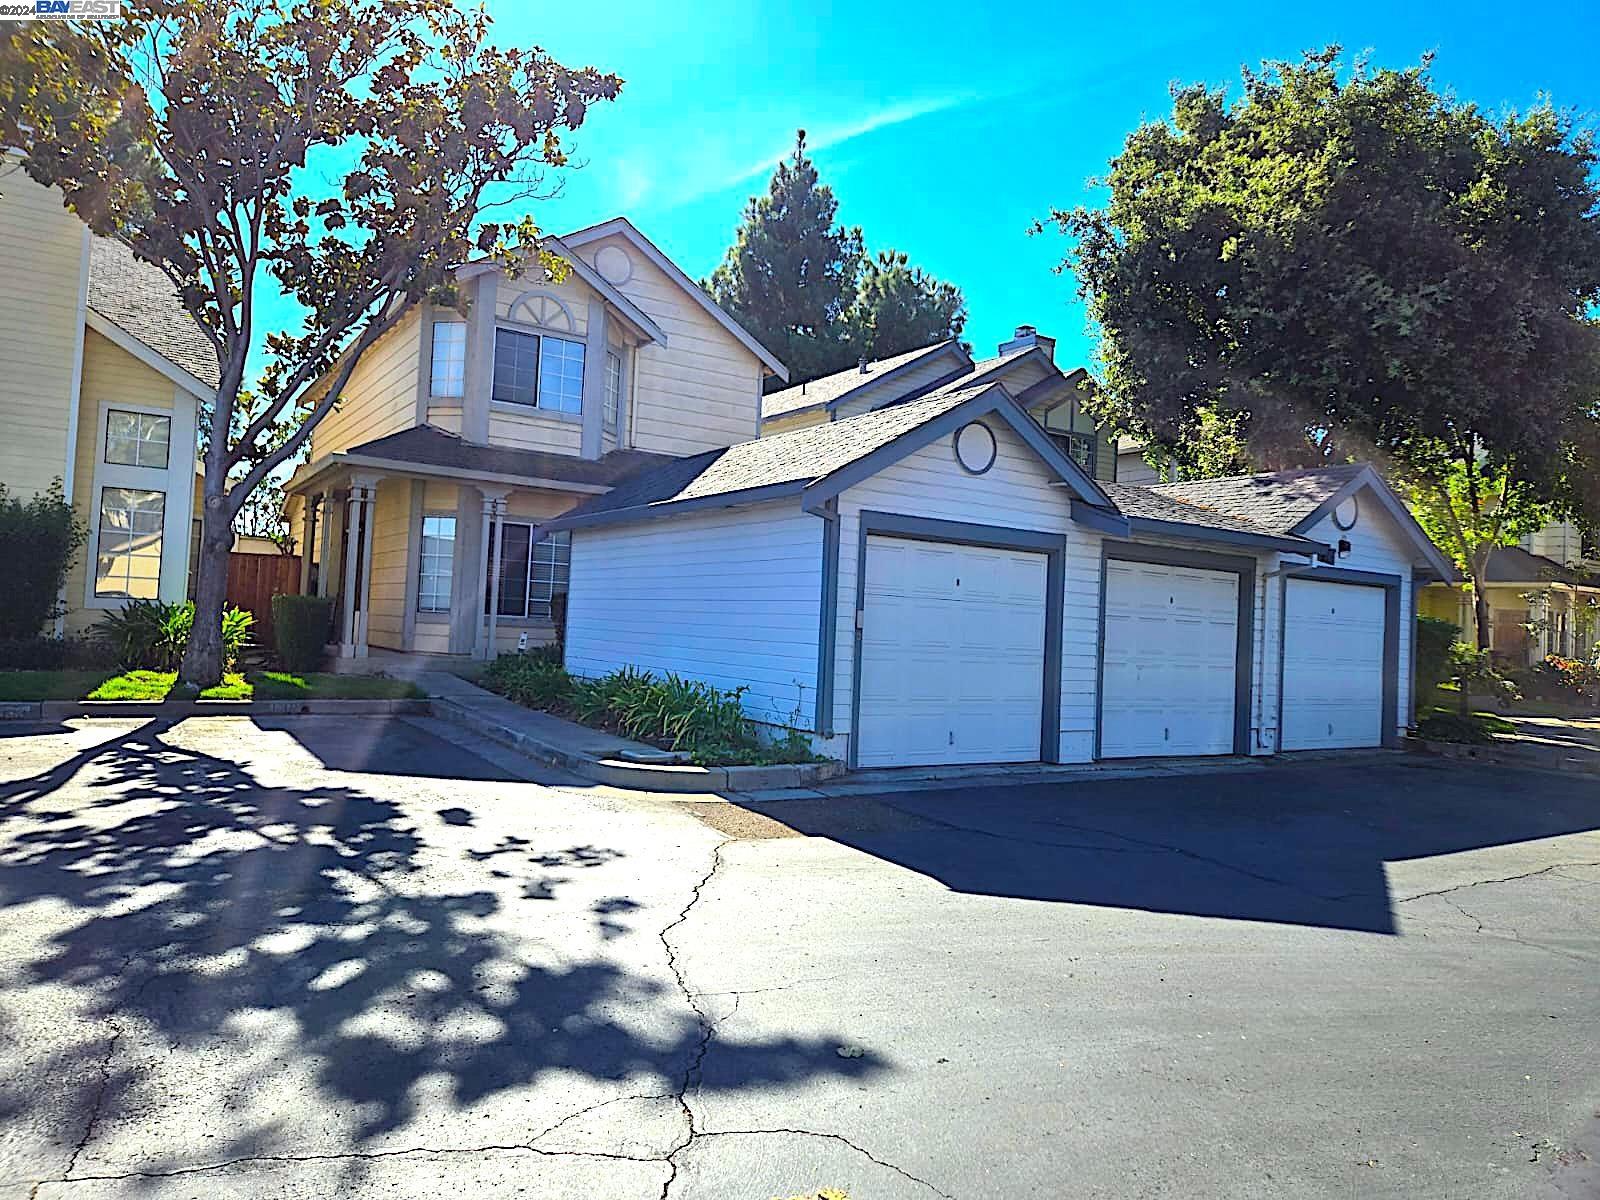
[1283,579,1386,750]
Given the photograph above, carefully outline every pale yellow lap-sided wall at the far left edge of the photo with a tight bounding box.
[0,155,86,496]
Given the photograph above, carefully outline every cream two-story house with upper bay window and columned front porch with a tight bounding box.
[286,218,787,658]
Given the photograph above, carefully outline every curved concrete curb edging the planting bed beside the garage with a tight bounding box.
[434,696,845,794]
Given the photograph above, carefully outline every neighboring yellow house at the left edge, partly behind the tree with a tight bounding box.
[0,155,218,632]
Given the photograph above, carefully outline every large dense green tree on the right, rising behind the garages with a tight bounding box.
[1051,46,1600,640]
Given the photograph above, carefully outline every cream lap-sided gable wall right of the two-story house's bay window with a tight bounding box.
[584,237,762,454]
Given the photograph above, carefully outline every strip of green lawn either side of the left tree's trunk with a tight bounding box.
[0,670,422,701]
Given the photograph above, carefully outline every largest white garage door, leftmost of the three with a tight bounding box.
[858,536,1046,766]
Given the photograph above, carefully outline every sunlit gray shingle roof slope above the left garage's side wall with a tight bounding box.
[550,384,994,517]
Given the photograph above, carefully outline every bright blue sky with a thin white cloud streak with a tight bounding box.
[265,0,1600,376]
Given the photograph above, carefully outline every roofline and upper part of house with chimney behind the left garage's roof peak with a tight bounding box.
[762,325,1118,482]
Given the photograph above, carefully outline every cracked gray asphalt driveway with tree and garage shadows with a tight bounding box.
[0,718,1600,1200]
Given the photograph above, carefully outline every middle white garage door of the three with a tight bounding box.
[1101,558,1238,758]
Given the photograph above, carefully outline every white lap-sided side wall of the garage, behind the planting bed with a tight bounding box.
[566,501,822,730]
